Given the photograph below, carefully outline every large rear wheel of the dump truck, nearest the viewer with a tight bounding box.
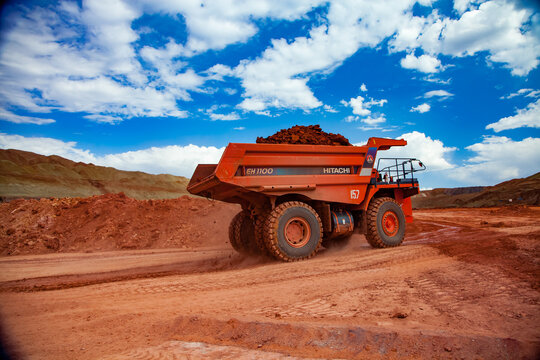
[264,201,322,261]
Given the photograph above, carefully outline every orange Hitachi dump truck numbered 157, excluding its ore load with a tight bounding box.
[188,138,425,261]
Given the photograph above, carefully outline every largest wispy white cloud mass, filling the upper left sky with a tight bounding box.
[0,0,332,124]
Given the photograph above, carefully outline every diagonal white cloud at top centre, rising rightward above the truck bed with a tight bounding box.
[234,0,414,111]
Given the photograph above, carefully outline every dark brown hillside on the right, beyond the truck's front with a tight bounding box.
[412,172,540,209]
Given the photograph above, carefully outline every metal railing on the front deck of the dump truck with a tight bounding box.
[377,158,426,184]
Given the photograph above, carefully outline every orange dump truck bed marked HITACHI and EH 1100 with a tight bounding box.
[188,138,414,204]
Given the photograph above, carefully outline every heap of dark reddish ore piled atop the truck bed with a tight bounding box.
[257,125,352,146]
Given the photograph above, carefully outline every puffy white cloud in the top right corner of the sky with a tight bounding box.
[390,0,540,76]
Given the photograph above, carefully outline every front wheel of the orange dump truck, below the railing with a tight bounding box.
[366,197,405,248]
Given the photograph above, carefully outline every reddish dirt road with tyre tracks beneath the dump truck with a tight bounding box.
[0,208,540,359]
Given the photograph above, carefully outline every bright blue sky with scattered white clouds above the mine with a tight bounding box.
[0,0,540,188]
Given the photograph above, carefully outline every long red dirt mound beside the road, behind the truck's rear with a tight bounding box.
[0,193,239,255]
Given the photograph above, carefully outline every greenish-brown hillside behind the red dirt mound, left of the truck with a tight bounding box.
[0,150,189,200]
